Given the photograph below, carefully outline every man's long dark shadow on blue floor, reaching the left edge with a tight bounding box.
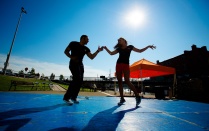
[0,104,66,131]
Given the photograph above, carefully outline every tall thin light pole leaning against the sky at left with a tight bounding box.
[3,7,27,75]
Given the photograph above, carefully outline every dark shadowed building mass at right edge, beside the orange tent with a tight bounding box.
[157,45,209,103]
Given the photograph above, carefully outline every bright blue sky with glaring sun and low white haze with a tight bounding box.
[0,0,209,77]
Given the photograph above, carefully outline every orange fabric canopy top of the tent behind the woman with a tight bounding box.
[130,59,176,78]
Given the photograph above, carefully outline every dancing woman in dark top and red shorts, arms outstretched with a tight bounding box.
[103,38,156,106]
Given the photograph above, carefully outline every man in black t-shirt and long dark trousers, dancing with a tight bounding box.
[63,35,102,105]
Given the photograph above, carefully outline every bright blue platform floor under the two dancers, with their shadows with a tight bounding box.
[0,92,209,131]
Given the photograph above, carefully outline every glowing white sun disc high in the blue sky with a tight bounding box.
[125,7,146,28]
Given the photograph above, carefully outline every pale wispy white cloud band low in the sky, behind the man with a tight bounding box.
[0,54,108,77]
